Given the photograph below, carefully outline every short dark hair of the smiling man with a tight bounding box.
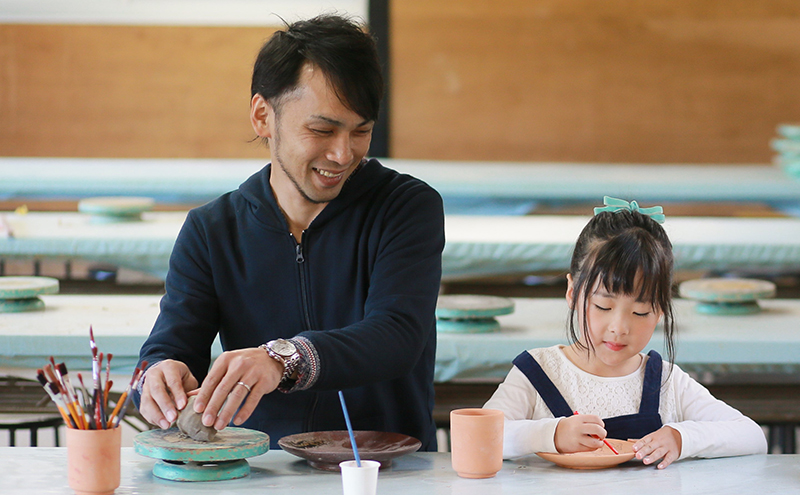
[250,15,383,121]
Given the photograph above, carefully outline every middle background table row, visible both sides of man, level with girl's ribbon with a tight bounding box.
[0,212,800,280]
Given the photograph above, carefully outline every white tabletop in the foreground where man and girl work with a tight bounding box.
[0,447,800,495]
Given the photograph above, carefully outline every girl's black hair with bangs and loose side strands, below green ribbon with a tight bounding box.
[567,210,675,363]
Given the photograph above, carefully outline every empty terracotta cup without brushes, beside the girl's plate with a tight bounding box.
[450,409,503,478]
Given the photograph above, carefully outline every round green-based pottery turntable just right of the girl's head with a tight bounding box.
[678,278,775,315]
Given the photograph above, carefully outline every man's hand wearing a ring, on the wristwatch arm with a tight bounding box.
[191,347,283,430]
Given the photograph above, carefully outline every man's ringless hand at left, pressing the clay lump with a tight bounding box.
[139,359,197,430]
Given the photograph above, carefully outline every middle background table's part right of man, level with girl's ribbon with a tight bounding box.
[442,215,800,279]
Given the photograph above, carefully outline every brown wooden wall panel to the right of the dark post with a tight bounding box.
[391,0,800,163]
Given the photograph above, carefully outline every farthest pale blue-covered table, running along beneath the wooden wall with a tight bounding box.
[0,157,800,214]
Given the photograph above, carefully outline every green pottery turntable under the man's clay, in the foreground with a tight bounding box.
[133,427,269,481]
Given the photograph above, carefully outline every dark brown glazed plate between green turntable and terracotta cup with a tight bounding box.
[278,430,422,471]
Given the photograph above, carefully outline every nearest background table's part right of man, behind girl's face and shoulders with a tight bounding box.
[436,298,800,382]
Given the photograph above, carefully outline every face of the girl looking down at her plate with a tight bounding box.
[567,275,662,376]
